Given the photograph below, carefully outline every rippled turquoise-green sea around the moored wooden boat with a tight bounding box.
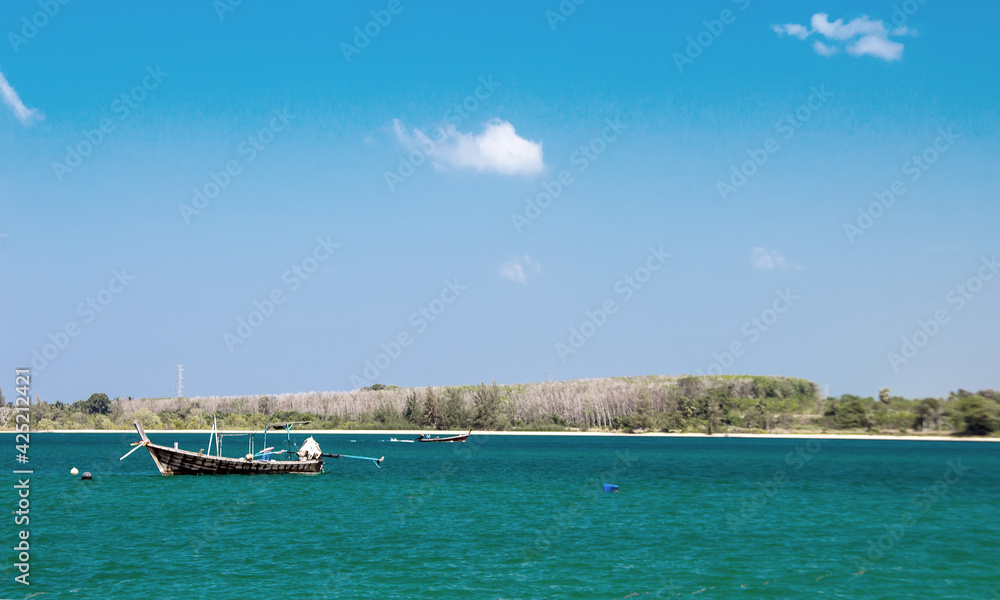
[0,433,1000,600]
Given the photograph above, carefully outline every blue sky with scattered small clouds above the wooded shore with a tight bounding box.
[0,0,1000,401]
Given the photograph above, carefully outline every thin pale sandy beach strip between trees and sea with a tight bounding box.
[0,429,1000,442]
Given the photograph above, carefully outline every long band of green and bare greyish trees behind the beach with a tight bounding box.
[0,375,1000,435]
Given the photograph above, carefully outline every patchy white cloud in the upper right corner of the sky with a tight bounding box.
[773,13,911,61]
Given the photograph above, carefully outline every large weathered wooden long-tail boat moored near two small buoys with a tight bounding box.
[119,421,385,475]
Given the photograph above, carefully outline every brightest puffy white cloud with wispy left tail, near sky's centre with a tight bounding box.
[392,119,545,175]
